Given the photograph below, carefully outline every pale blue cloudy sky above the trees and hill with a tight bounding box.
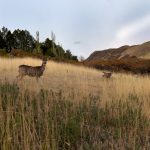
[0,0,150,58]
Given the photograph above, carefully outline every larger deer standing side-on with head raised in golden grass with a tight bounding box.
[17,59,47,81]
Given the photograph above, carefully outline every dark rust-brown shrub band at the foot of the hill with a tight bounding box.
[84,57,150,74]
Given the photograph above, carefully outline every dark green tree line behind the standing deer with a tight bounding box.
[0,27,78,61]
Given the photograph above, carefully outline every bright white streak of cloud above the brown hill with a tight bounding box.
[117,14,150,40]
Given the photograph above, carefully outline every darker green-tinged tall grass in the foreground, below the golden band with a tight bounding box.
[0,82,150,150]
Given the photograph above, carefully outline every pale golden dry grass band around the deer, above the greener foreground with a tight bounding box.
[0,58,150,108]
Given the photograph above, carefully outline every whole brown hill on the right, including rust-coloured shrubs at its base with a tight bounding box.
[84,42,150,74]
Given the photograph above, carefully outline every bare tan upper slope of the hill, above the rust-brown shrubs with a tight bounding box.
[86,42,150,62]
